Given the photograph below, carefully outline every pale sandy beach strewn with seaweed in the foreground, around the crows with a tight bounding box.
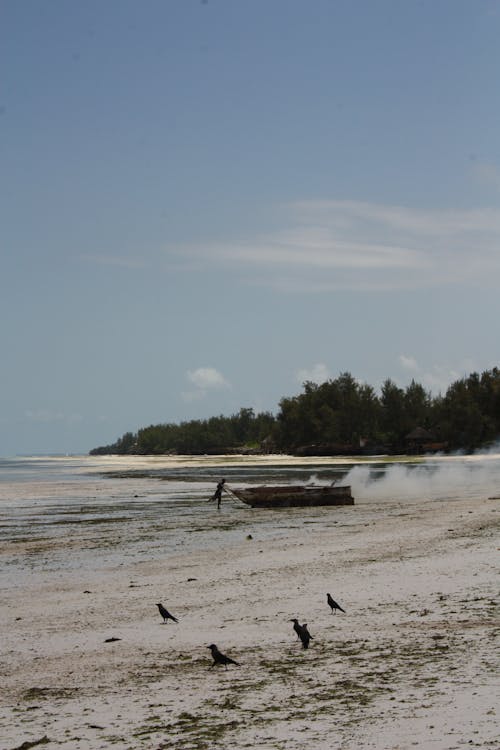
[0,458,500,750]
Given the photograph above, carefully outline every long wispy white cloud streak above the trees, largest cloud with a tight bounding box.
[167,201,500,292]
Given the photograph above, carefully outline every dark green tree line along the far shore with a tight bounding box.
[90,367,500,455]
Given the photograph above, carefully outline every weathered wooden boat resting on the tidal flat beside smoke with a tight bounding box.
[230,484,354,508]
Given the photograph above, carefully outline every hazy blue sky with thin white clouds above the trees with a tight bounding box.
[0,0,500,456]
